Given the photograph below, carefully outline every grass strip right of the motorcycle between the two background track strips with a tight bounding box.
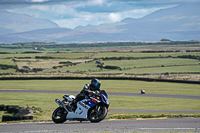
[109,96,200,112]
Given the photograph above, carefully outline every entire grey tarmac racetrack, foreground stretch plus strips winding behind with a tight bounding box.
[0,89,200,133]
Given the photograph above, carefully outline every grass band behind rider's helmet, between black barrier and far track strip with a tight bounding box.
[0,80,200,95]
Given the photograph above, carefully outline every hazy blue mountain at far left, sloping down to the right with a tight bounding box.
[0,11,59,35]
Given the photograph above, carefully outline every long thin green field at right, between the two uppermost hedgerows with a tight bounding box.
[93,52,200,58]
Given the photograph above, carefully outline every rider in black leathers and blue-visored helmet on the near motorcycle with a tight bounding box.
[71,78,101,111]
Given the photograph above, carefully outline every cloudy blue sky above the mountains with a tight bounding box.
[0,0,200,29]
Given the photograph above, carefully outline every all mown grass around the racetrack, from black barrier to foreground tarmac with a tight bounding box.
[0,80,200,121]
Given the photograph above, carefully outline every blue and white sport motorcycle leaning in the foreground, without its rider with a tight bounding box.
[52,90,110,123]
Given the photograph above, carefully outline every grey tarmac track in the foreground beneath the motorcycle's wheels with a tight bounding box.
[0,117,200,133]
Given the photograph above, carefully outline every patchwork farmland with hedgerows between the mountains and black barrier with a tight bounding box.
[0,41,200,81]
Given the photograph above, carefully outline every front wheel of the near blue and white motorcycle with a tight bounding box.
[88,106,107,123]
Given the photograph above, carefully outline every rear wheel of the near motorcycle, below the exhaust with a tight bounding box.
[52,107,67,123]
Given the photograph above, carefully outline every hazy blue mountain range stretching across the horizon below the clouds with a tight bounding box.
[0,4,200,43]
